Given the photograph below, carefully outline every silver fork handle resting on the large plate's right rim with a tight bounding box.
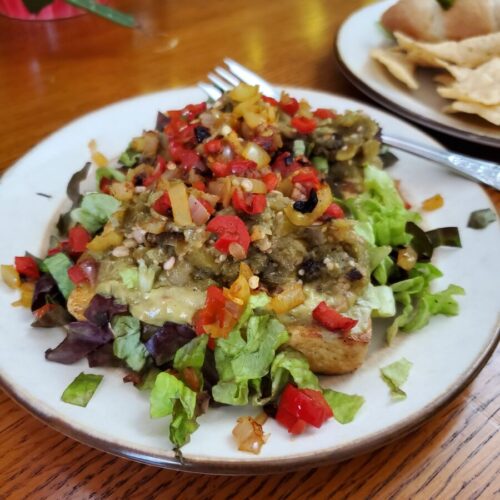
[382,134,500,190]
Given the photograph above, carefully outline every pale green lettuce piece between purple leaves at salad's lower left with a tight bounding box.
[112,316,149,372]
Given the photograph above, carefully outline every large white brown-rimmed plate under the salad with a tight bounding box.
[0,88,500,474]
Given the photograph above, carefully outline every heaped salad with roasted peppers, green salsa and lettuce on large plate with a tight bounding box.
[1,84,464,453]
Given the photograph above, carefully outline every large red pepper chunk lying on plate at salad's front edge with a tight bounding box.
[276,384,333,434]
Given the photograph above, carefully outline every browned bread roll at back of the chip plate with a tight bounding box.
[381,0,500,42]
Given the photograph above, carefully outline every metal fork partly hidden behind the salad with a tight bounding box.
[198,58,500,190]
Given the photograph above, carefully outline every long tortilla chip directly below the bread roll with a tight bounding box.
[394,32,500,68]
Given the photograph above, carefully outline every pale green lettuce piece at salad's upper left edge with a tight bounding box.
[71,193,121,233]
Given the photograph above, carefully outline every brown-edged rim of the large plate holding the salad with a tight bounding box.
[0,87,500,475]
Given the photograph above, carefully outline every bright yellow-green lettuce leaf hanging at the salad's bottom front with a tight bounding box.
[149,372,196,418]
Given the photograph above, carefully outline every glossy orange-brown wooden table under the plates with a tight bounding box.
[0,0,500,499]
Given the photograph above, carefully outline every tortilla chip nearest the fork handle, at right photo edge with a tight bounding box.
[437,57,500,106]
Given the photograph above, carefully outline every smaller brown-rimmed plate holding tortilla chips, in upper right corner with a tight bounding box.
[337,0,500,147]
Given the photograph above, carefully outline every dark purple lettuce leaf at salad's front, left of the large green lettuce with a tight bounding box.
[145,321,196,366]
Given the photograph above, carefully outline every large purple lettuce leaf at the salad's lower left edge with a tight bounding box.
[45,321,114,365]
